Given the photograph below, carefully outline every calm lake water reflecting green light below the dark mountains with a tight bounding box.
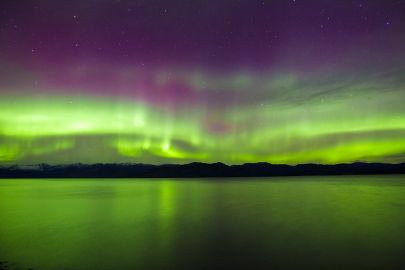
[0,175,405,270]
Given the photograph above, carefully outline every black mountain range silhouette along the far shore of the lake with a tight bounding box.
[0,162,405,178]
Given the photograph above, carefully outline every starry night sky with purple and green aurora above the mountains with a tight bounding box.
[0,0,405,164]
